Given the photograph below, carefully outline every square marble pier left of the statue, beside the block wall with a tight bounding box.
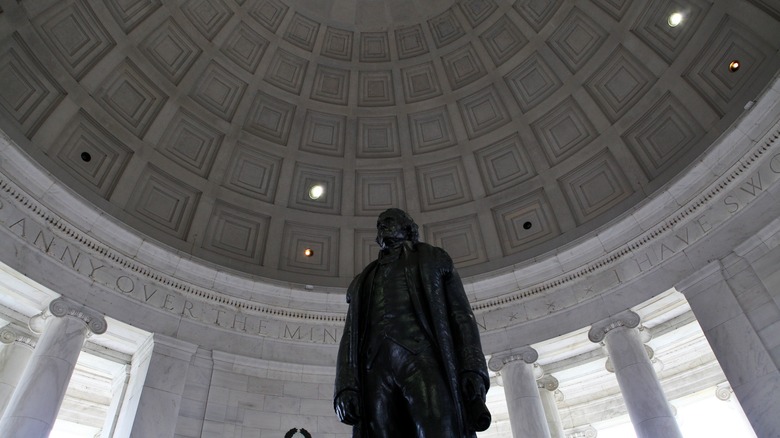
[114,333,198,438]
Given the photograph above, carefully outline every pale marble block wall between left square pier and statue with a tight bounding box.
[175,350,352,438]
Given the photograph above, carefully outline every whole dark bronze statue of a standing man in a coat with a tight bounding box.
[333,208,491,438]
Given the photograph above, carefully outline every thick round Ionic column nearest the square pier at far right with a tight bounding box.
[588,310,682,438]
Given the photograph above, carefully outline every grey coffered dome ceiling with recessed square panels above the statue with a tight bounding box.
[0,0,780,286]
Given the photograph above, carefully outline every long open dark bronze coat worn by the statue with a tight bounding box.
[334,241,490,438]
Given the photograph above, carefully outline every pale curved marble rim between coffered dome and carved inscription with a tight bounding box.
[3,72,780,321]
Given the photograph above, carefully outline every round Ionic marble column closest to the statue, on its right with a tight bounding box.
[488,347,550,438]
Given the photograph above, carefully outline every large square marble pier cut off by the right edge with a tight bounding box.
[675,254,780,437]
